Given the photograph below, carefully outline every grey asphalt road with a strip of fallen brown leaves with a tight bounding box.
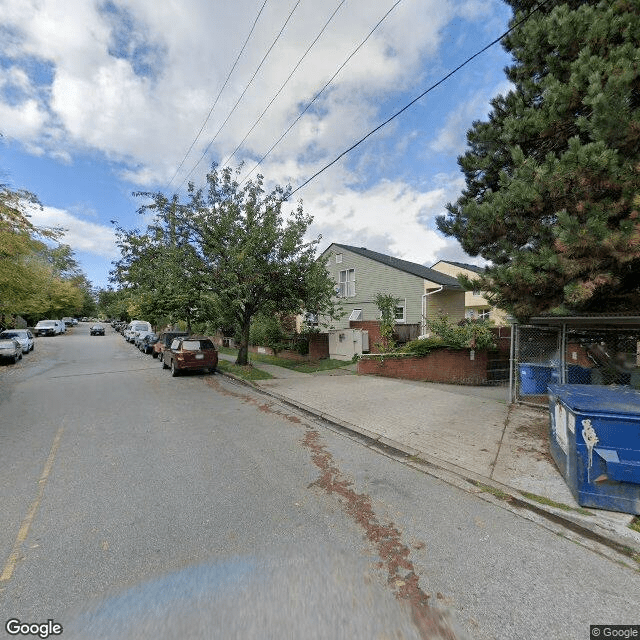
[0,325,640,639]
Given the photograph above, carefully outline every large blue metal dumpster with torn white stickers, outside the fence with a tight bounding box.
[549,384,640,515]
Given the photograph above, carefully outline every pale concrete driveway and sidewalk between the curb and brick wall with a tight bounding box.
[220,354,640,553]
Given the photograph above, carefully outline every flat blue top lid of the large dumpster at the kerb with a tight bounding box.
[549,384,640,416]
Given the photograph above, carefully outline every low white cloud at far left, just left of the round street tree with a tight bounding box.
[29,202,119,258]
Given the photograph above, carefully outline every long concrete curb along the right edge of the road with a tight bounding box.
[218,370,640,570]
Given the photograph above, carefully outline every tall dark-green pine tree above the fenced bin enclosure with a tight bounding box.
[437,0,640,319]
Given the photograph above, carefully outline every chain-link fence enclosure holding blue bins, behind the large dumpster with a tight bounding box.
[511,325,640,405]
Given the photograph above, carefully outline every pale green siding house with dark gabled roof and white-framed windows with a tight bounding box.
[319,243,465,334]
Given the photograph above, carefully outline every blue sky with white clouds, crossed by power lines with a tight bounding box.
[0,0,511,286]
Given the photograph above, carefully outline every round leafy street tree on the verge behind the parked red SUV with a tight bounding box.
[119,166,340,365]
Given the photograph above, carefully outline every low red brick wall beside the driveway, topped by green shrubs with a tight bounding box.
[358,349,488,384]
